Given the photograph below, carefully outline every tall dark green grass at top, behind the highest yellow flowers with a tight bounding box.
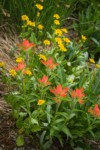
[1,0,75,31]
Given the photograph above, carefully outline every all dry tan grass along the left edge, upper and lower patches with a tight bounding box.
[0,21,20,114]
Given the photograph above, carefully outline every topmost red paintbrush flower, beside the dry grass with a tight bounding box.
[18,39,36,50]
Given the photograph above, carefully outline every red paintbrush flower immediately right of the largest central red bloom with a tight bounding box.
[71,88,85,99]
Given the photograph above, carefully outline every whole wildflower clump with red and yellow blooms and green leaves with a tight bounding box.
[0,1,100,150]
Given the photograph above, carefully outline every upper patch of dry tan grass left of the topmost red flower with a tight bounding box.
[0,21,19,70]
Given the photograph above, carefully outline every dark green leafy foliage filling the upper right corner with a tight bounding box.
[73,0,100,56]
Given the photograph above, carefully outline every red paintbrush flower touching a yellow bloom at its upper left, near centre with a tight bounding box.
[41,57,58,69]
